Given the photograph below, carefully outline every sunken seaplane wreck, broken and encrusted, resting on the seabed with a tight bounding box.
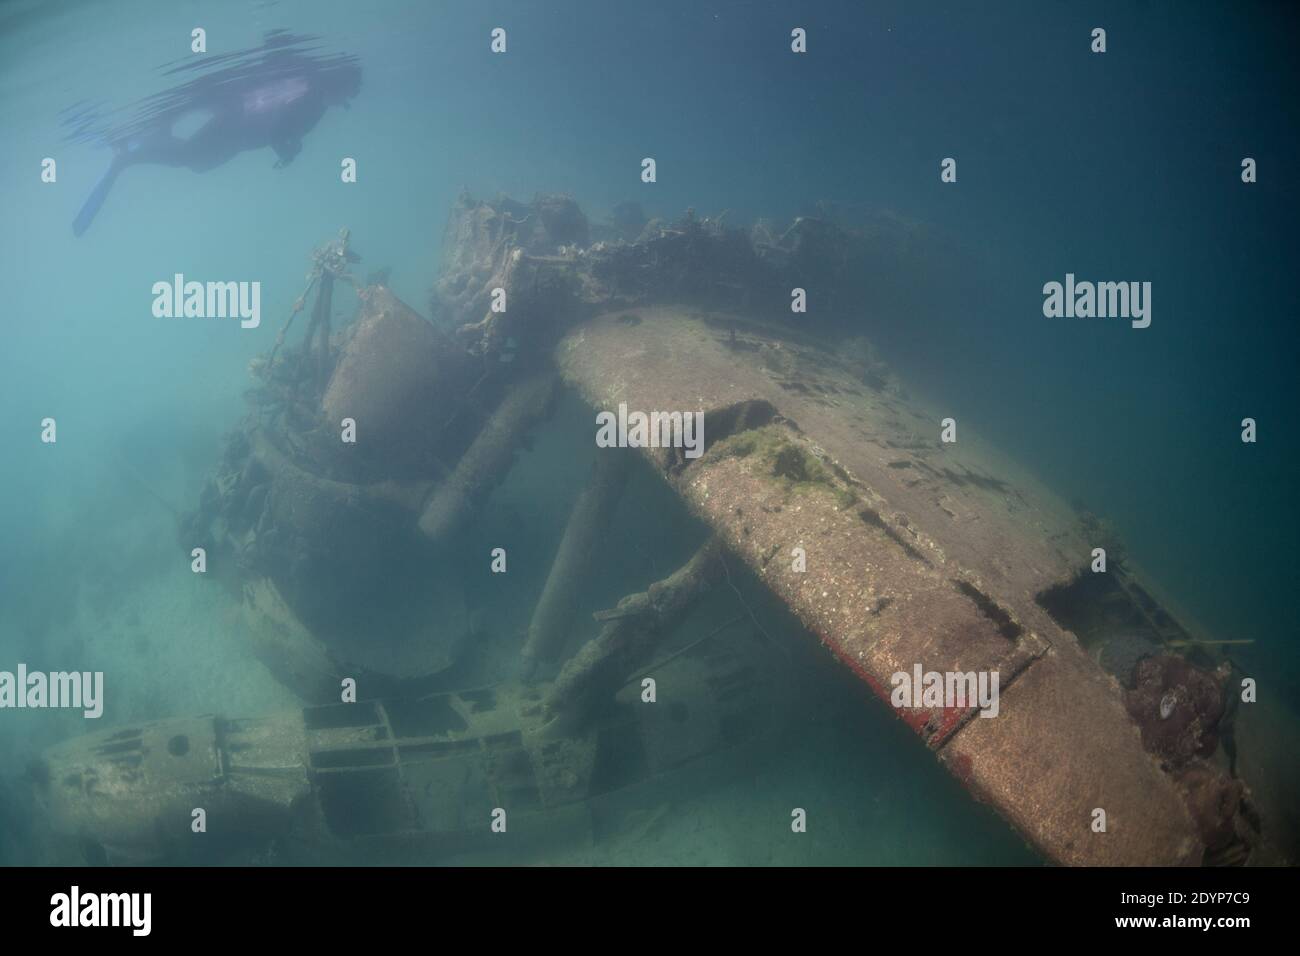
[27,196,1265,865]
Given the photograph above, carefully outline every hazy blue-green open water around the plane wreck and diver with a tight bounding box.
[0,0,1300,864]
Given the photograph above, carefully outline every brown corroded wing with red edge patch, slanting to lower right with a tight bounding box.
[556,308,1204,865]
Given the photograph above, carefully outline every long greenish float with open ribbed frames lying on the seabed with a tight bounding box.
[33,637,781,864]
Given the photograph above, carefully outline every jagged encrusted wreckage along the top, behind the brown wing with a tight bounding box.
[430,195,872,355]
